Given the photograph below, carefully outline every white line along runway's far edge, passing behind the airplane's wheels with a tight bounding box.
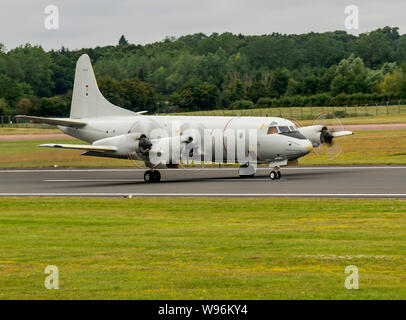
[0,166,406,173]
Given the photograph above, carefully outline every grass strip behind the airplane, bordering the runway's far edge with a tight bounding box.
[0,130,406,168]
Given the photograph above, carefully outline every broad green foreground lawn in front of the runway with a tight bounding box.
[0,198,406,299]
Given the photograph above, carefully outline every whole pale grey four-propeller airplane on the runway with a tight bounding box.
[18,54,353,182]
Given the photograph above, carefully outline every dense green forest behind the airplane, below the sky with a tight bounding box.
[0,27,406,116]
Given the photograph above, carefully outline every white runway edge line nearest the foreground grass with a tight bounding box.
[0,193,406,198]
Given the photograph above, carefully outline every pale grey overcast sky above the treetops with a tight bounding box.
[0,0,406,50]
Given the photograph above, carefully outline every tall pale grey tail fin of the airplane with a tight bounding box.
[70,54,136,119]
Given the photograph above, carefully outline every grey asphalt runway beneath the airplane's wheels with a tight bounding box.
[0,166,406,198]
